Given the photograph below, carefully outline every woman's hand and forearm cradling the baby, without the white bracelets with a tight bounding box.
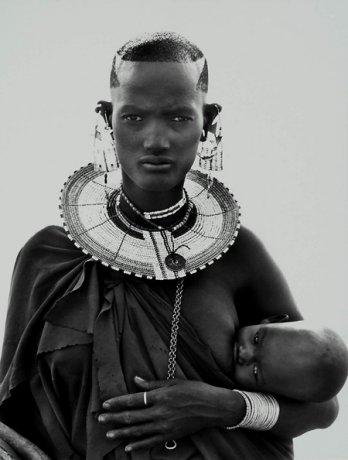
[99,378,337,450]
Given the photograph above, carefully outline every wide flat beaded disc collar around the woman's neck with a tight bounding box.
[59,164,240,280]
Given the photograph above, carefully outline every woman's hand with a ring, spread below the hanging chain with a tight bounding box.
[98,377,244,452]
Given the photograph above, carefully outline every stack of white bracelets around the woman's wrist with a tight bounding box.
[225,390,279,431]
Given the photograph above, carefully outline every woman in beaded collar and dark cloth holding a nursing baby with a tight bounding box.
[0,33,337,460]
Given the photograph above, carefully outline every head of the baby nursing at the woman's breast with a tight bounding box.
[234,321,348,401]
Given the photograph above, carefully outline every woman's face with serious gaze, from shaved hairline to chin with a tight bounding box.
[111,62,204,191]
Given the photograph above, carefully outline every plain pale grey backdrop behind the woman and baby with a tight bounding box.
[0,0,348,460]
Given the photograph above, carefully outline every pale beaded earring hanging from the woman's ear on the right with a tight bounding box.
[197,105,223,171]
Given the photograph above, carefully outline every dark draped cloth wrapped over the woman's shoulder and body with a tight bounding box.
[0,227,293,460]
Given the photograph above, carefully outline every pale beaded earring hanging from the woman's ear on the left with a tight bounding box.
[93,113,120,173]
